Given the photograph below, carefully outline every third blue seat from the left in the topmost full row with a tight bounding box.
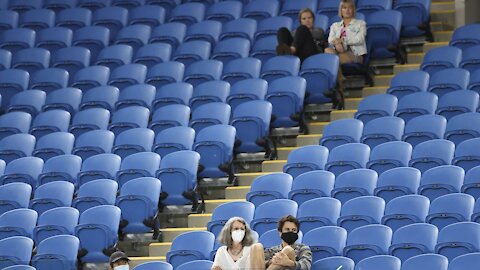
[55,7,92,31]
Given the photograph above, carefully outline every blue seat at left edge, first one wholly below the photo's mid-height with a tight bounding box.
[0,133,36,164]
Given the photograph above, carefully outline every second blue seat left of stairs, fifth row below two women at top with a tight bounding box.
[115,149,160,187]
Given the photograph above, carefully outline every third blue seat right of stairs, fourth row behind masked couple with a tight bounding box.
[402,114,447,147]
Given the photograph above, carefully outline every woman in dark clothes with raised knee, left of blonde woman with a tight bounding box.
[277,8,325,62]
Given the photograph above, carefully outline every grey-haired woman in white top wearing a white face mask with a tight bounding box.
[212,217,255,270]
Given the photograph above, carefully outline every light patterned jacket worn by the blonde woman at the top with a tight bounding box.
[328,19,367,55]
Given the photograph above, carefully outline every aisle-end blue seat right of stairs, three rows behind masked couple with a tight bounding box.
[283,145,328,178]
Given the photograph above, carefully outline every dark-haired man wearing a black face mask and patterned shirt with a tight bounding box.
[265,215,312,270]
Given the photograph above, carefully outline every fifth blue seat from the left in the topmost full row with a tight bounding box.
[128,5,167,28]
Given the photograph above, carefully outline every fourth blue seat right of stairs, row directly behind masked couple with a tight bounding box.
[337,196,385,233]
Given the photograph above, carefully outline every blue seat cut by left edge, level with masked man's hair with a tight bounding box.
[0,208,38,240]
